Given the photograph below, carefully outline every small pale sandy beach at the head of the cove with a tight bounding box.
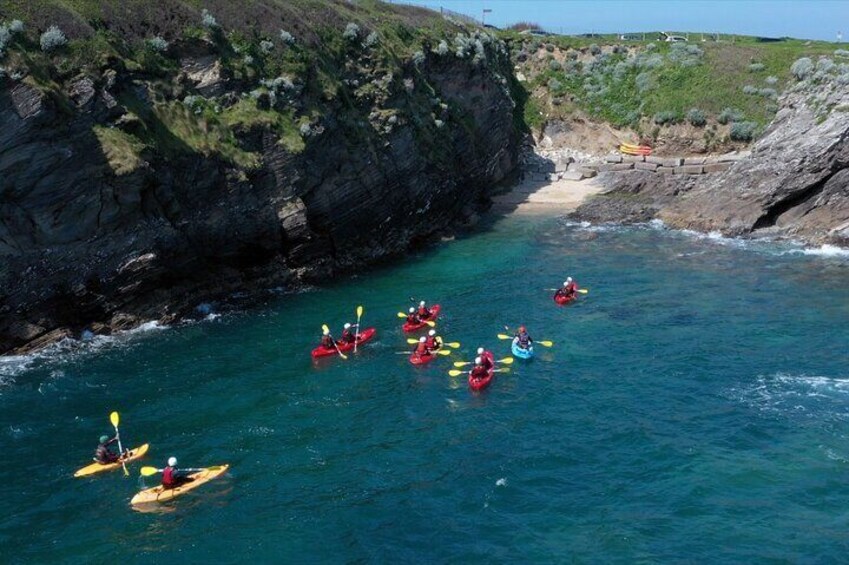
[492,178,604,213]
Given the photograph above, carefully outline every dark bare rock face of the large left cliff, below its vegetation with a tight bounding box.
[0,28,520,353]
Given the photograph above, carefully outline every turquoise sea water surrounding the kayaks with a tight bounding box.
[0,216,849,564]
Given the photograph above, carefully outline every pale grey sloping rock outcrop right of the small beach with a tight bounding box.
[579,74,849,245]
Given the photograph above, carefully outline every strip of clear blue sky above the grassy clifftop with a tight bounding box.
[392,0,849,41]
